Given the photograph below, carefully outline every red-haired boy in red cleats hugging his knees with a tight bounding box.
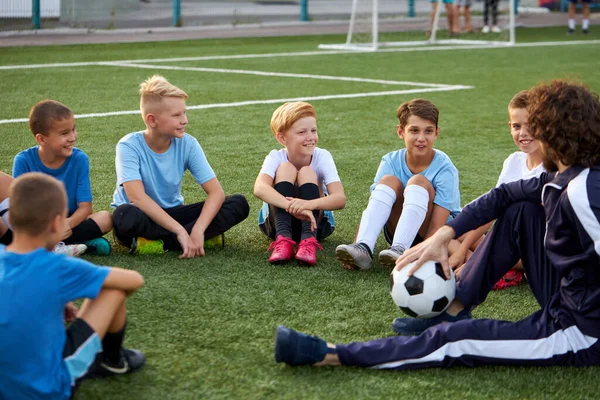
[254,101,346,265]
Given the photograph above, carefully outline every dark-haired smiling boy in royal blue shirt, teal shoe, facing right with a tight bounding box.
[13,100,112,255]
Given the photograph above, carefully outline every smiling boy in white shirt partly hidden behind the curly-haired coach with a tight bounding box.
[449,90,544,290]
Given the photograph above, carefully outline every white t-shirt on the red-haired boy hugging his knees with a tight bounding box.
[260,147,340,194]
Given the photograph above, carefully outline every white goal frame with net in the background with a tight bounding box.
[319,0,516,51]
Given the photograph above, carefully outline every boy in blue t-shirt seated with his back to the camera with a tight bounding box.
[0,172,145,400]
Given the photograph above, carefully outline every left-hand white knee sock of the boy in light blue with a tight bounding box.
[356,184,396,252]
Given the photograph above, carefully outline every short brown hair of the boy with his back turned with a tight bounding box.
[9,172,67,236]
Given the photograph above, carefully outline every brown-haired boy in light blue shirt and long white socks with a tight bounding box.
[336,99,460,269]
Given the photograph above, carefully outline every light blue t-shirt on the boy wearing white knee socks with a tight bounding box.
[371,149,460,218]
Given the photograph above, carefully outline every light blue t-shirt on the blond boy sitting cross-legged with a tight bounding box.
[111,132,215,208]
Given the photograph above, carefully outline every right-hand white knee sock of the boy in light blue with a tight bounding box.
[392,185,429,250]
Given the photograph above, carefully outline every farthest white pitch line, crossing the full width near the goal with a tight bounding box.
[0,40,600,70]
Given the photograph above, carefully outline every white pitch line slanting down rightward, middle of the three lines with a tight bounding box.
[105,62,449,88]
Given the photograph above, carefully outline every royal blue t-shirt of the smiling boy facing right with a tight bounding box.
[13,146,92,215]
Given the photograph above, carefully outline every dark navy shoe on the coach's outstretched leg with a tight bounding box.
[275,325,335,365]
